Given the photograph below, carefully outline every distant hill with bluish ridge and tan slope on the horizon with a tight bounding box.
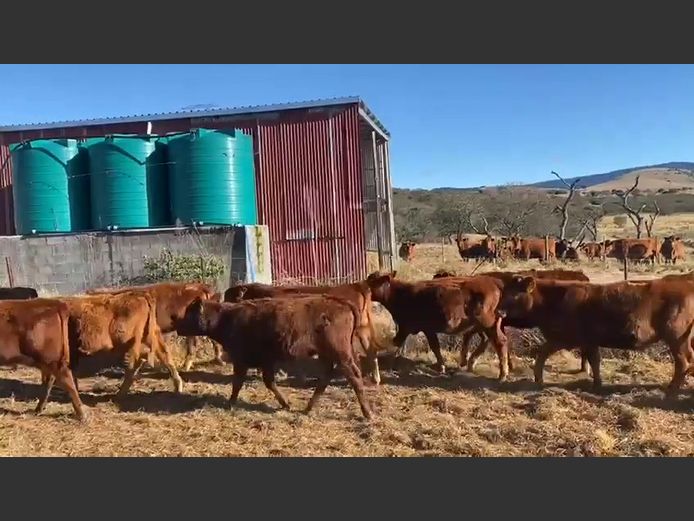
[527,161,694,191]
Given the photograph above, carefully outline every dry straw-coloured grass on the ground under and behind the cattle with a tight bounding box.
[0,245,694,456]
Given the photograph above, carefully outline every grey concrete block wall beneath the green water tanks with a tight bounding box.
[0,226,272,295]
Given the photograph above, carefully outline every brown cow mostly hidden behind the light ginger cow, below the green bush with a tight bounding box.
[87,282,224,371]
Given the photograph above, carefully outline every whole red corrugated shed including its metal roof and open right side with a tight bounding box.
[0,97,395,282]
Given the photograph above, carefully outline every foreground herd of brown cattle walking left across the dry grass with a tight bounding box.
[0,260,694,419]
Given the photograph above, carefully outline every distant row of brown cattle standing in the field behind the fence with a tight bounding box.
[399,234,685,264]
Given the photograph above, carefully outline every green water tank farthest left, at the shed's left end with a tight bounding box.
[11,139,89,235]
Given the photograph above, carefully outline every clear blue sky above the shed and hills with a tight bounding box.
[0,65,694,188]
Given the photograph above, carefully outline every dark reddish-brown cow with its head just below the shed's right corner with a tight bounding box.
[367,272,508,381]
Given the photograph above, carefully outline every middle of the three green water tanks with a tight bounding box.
[87,135,171,230]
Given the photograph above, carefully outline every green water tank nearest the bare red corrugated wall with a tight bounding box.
[168,129,258,225]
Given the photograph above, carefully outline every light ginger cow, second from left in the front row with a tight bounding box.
[60,291,183,398]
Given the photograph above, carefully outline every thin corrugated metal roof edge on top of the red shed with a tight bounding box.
[0,96,390,137]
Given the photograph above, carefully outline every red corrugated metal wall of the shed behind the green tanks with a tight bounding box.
[0,104,391,282]
